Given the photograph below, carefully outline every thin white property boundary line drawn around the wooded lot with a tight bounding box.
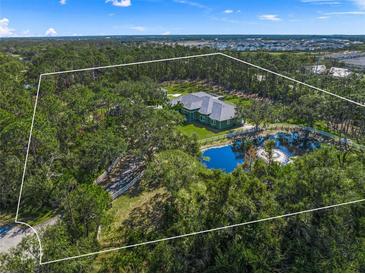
[15,52,365,265]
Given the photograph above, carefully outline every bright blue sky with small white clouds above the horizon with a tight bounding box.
[0,0,365,37]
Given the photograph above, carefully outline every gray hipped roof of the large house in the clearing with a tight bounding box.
[171,91,236,121]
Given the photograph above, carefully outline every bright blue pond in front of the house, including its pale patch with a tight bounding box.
[202,133,320,173]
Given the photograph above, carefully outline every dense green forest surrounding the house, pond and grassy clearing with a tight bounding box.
[0,40,365,272]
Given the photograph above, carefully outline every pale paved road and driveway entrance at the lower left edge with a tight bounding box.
[0,217,58,252]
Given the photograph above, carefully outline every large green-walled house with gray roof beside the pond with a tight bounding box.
[171,92,240,130]
